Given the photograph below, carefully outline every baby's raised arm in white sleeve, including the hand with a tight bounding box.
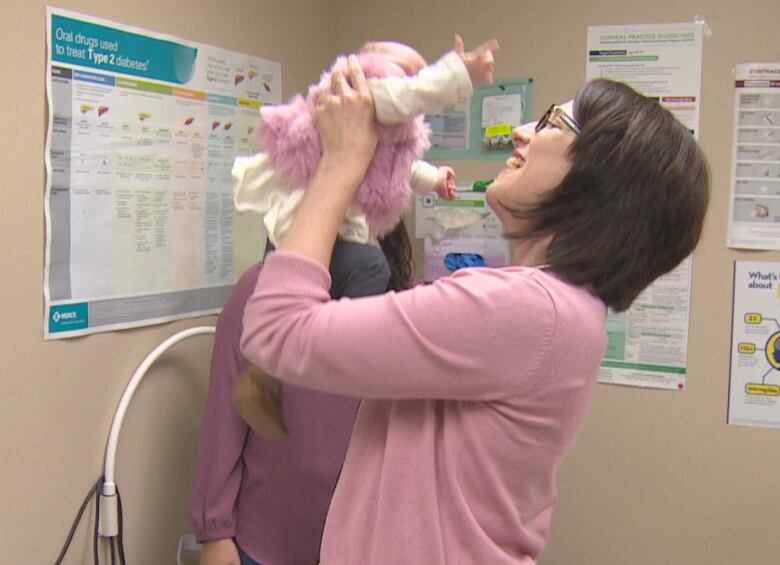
[368,35,498,124]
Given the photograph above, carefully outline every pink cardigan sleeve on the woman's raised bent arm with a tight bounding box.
[241,252,556,400]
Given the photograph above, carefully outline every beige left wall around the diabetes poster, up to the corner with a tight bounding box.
[0,0,335,565]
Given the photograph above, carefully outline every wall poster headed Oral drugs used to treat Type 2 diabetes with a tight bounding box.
[44,8,281,339]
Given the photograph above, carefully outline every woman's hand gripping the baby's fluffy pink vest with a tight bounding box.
[314,55,378,182]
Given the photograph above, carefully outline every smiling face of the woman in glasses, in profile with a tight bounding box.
[486,102,577,233]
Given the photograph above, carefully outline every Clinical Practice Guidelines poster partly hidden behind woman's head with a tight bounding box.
[587,22,705,390]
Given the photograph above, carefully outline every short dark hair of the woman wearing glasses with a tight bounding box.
[509,79,710,312]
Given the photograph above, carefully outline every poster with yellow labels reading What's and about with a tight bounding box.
[728,261,780,428]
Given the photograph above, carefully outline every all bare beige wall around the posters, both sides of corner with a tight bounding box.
[0,0,780,565]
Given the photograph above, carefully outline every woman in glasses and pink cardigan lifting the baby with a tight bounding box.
[241,55,709,565]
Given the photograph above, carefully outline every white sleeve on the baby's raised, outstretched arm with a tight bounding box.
[368,51,472,124]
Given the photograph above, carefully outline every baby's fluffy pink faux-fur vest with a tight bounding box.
[256,52,430,235]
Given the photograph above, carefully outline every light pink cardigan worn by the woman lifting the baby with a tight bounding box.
[241,252,606,565]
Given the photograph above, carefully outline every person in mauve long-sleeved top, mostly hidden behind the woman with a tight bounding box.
[190,223,414,565]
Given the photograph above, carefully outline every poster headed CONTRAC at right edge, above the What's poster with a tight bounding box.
[728,63,780,250]
